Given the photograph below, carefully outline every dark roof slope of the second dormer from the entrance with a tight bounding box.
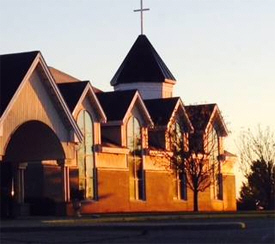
[96,90,136,121]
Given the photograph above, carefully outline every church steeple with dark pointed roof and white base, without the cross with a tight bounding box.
[111,35,176,99]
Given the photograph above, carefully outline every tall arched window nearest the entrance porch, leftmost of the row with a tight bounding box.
[77,110,96,199]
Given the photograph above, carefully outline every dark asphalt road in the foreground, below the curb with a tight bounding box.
[1,218,275,244]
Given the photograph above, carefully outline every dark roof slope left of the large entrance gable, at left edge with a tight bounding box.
[0,51,39,116]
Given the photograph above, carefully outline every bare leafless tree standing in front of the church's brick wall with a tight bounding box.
[166,117,222,212]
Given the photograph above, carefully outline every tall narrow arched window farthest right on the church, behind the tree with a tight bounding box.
[208,129,223,200]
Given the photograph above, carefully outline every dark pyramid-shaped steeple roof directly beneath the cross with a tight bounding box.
[111,35,176,86]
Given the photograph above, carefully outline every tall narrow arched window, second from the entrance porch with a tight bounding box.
[127,117,145,200]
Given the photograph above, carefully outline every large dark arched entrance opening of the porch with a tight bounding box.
[1,121,66,217]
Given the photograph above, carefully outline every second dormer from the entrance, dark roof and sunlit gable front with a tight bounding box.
[97,90,153,148]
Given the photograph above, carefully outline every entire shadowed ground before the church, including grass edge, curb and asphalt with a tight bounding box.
[0,212,275,244]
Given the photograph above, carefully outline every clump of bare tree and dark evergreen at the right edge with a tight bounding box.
[238,126,275,209]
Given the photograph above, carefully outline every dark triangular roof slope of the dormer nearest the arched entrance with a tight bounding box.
[57,81,89,112]
